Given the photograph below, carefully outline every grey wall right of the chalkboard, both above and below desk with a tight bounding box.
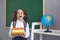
[43,0,60,40]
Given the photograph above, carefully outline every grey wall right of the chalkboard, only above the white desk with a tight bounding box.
[46,0,60,29]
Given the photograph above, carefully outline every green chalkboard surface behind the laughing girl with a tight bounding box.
[6,0,43,28]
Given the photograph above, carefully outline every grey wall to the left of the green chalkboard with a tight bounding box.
[0,0,11,40]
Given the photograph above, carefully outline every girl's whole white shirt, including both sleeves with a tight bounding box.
[9,20,30,38]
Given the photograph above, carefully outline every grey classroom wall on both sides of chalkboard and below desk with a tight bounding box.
[0,0,60,40]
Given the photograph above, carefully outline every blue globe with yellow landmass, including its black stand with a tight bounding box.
[41,14,54,32]
